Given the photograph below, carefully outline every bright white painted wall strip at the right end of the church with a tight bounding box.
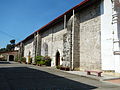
[101,0,115,70]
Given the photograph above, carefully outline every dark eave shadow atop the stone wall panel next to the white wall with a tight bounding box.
[78,0,104,23]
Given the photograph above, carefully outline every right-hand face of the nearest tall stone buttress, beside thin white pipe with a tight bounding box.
[72,14,80,69]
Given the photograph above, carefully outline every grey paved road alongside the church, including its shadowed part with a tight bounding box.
[0,62,120,90]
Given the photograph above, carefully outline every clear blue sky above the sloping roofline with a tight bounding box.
[0,0,83,48]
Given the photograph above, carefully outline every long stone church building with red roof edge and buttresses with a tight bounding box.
[17,0,120,73]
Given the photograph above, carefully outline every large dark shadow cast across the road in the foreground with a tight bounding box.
[0,67,97,90]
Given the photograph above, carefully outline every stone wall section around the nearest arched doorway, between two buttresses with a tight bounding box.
[41,22,66,66]
